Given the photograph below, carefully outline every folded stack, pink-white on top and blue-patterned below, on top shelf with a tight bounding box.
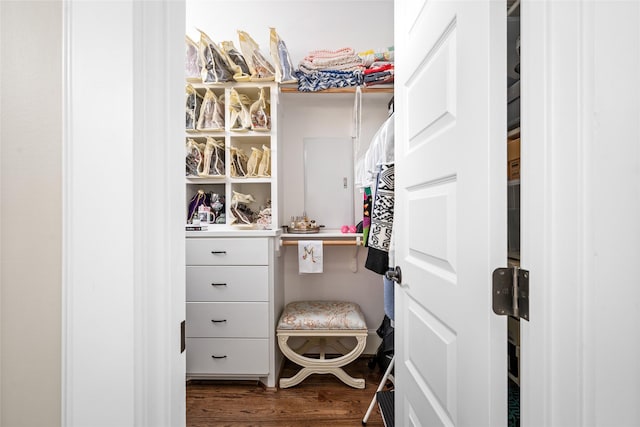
[296,47,365,92]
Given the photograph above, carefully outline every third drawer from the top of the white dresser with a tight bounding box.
[186,302,269,338]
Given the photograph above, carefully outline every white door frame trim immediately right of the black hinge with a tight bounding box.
[520,0,594,427]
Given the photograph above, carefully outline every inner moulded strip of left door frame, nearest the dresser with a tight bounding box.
[133,0,186,427]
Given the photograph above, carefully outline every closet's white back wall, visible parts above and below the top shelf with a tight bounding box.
[186,0,393,342]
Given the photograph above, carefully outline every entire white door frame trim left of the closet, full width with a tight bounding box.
[61,0,185,426]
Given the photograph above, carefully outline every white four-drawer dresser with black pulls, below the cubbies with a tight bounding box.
[186,231,283,387]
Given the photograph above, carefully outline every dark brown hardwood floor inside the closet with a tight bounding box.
[187,357,383,427]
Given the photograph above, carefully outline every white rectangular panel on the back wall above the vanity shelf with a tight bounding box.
[303,137,359,229]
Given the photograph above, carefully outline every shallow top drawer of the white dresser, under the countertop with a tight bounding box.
[186,237,269,265]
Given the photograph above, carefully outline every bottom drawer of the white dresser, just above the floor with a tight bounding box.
[186,338,269,376]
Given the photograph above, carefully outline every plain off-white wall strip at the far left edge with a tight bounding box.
[0,0,62,427]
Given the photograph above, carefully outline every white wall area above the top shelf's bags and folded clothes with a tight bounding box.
[186,0,393,64]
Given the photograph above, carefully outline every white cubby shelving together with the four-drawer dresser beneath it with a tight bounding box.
[185,82,284,387]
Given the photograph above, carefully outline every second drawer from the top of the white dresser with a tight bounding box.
[186,265,269,301]
